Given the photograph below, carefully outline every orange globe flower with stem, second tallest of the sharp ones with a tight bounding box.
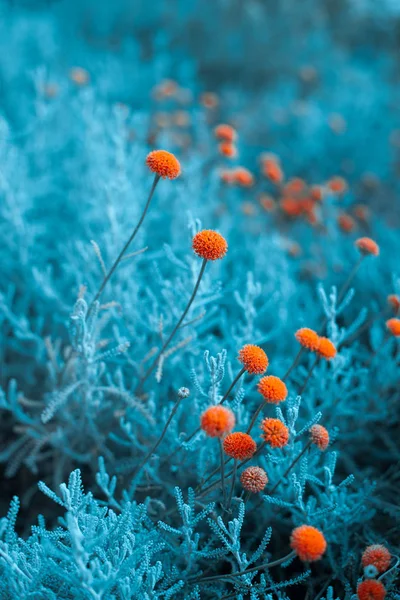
[135,229,228,394]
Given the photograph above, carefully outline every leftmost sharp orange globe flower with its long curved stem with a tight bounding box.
[88,150,181,316]
